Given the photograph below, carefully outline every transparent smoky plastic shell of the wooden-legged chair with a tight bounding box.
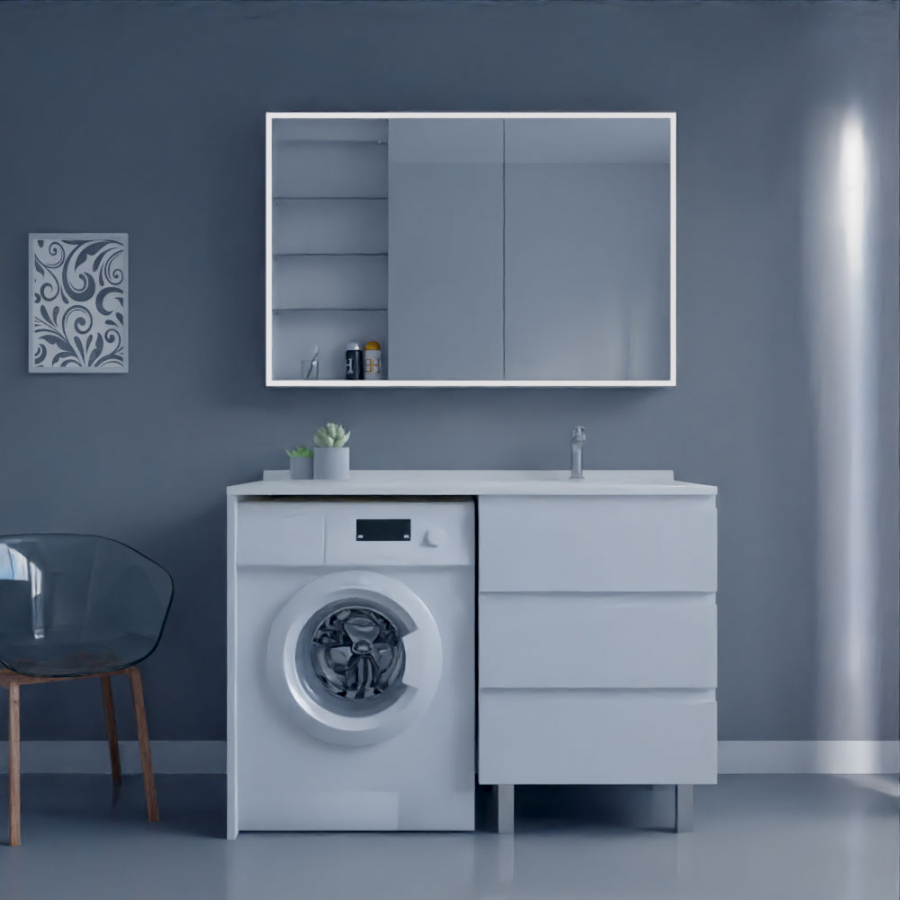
[0,534,173,674]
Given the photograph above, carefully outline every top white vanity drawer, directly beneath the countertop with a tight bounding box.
[479,495,716,593]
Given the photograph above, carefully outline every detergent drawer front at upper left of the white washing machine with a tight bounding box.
[235,501,325,566]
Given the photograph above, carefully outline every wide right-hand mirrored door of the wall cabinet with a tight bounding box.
[504,118,673,381]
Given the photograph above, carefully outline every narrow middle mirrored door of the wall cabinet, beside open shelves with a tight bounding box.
[388,118,503,380]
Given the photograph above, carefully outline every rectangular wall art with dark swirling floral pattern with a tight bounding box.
[28,234,128,373]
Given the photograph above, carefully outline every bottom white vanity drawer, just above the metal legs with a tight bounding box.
[478,690,717,784]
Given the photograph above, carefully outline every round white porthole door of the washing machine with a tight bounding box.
[268,571,443,746]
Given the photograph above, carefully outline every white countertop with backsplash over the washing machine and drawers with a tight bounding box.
[228,469,718,497]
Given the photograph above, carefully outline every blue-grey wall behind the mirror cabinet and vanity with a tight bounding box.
[0,0,898,739]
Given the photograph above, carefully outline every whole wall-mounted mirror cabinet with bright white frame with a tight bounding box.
[266,113,676,388]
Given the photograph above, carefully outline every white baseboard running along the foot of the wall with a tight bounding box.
[0,741,900,775]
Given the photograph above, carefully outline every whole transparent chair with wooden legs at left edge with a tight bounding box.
[0,534,172,846]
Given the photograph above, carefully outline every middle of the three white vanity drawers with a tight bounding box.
[478,594,716,688]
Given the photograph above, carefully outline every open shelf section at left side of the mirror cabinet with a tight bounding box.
[271,119,388,381]
